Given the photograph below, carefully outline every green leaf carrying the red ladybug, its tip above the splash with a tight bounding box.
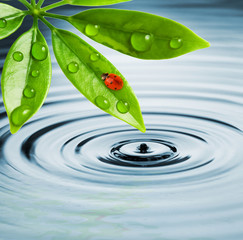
[52,29,146,132]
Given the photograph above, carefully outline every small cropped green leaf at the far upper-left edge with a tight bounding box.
[0,3,25,39]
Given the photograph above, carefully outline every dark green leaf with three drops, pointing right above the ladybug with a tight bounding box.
[68,9,210,59]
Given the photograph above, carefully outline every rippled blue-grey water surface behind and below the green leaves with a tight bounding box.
[0,0,243,240]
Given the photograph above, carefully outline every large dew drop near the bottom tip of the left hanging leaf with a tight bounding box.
[11,105,31,126]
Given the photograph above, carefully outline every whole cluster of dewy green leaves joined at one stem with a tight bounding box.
[0,0,209,133]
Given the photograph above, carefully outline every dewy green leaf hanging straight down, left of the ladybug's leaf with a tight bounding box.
[1,28,51,133]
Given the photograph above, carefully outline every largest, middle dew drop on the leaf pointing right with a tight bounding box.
[131,32,152,52]
